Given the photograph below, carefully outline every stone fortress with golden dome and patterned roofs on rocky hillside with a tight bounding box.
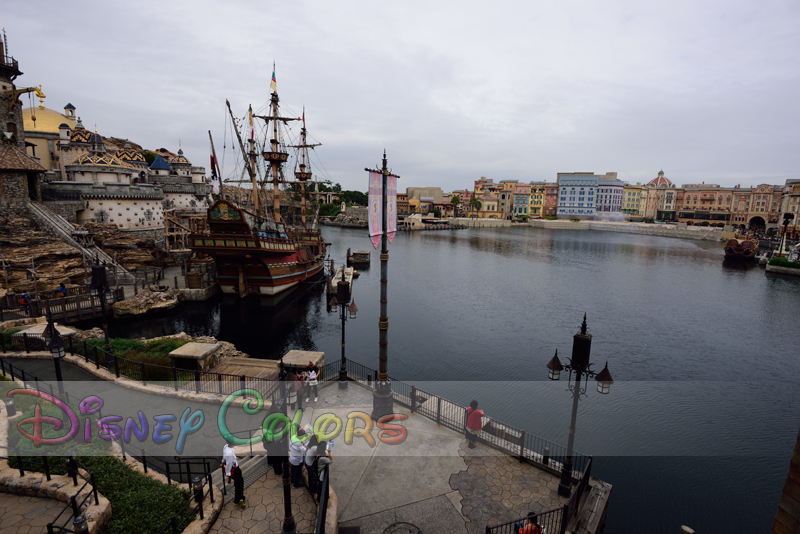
[22,96,211,244]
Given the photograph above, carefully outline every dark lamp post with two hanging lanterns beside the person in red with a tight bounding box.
[547,314,614,497]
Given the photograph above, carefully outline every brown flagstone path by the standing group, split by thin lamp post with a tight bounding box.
[208,469,317,534]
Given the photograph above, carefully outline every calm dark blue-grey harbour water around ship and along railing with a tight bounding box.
[106,227,800,534]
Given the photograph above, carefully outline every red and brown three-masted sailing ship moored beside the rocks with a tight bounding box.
[190,84,326,297]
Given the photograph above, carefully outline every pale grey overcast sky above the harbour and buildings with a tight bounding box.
[0,0,800,191]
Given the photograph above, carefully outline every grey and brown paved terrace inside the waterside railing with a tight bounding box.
[302,382,567,534]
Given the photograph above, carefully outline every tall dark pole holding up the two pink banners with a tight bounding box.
[365,150,399,420]
